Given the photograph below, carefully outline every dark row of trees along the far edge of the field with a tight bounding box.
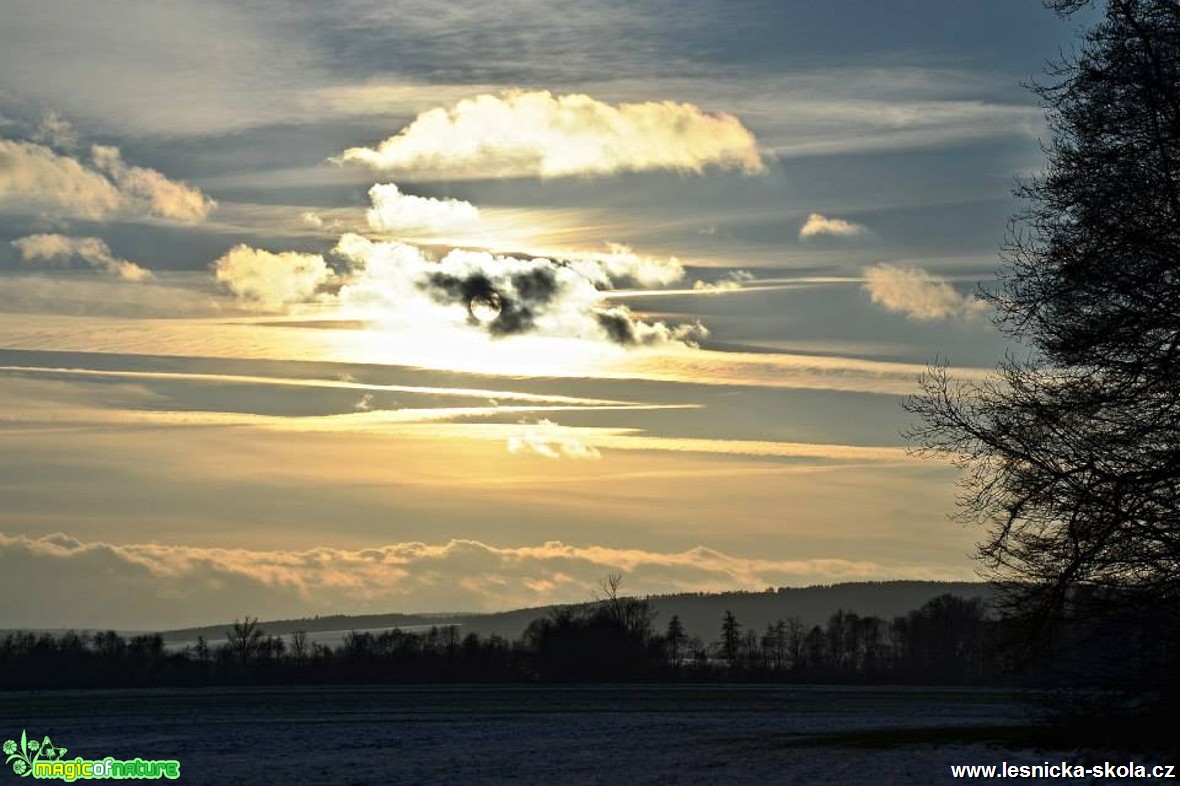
[0,583,1003,689]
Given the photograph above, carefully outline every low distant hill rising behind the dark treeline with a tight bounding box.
[154,581,994,646]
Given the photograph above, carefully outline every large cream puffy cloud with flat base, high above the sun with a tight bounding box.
[339,91,763,177]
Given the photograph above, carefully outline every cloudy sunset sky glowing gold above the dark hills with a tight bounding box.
[0,0,1086,629]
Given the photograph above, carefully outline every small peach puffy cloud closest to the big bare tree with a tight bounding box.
[864,264,989,322]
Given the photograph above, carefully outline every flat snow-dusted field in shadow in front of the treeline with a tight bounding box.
[0,686,1161,785]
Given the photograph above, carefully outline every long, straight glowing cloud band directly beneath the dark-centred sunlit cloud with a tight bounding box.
[0,314,990,395]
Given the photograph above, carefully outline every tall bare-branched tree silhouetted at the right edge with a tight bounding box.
[909,0,1180,722]
